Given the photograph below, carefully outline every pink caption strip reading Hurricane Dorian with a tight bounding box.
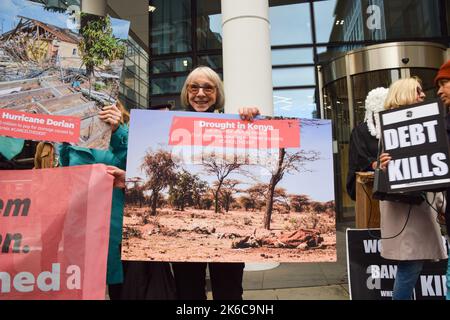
[0,109,80,143]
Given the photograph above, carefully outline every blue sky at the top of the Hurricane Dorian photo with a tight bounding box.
[0,0,130,39]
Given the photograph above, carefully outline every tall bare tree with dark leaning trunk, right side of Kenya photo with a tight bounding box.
[264,148,319,230]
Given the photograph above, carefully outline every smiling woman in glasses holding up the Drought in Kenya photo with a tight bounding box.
[172,66,259,300]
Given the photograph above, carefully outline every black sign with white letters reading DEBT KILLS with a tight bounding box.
[380,101,450,192]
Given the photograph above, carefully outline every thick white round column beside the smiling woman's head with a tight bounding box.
[222,0,273,115]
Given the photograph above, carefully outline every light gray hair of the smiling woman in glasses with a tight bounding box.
[180,66,225,110]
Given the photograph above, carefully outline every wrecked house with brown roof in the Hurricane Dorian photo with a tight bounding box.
[0,16,82,68]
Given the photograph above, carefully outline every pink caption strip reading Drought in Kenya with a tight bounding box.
[169,117,300,149]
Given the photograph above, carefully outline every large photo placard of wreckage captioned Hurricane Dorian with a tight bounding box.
[0,0,130,149]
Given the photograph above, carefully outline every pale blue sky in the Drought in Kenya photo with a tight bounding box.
[127,110,334,201]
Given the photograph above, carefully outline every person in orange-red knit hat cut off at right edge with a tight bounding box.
[434,60,450,300]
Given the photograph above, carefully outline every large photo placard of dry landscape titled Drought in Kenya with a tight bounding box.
[122,110,336,262]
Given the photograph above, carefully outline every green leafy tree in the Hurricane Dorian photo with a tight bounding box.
[79,12,125,79]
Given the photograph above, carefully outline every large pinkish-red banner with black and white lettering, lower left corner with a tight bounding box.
[0,165,113,300]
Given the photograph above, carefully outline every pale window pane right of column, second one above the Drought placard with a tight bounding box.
[272,67,315,87]
